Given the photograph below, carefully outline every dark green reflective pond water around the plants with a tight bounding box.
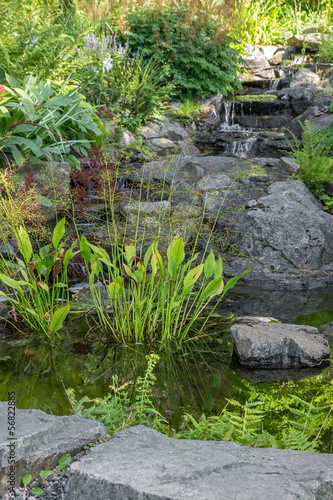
[0,288,333,451]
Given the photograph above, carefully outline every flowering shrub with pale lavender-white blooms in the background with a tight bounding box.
[74,34,173,126]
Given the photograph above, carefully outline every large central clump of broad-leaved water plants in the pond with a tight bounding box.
[80,236,248,345]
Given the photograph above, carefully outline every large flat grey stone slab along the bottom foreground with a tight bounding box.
[65,426,333,500]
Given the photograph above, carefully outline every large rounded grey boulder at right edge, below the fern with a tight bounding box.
[231,181,333,272]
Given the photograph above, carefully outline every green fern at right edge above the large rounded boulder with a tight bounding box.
[287,120,333,189]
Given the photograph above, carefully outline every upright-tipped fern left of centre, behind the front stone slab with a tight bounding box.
[66,354,165,435]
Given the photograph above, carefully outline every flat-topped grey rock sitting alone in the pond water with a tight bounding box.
[230,320,331,369]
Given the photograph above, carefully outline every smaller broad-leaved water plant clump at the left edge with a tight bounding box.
[0,219,76,338]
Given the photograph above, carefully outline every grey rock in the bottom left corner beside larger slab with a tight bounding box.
[0,402,107,495]
